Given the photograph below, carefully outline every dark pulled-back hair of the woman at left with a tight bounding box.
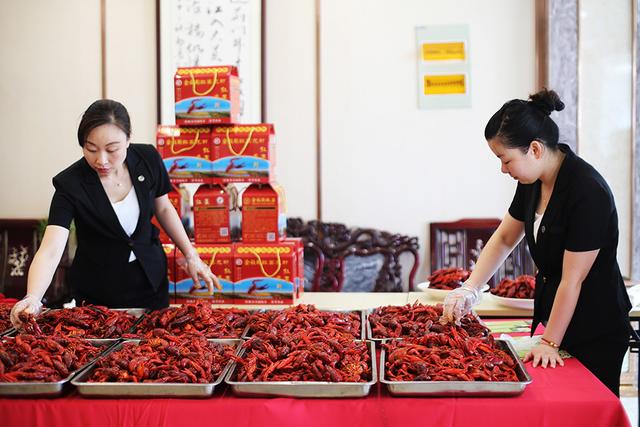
[78,99,131,147]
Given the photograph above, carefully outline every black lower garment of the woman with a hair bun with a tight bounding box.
[567,330,629,397]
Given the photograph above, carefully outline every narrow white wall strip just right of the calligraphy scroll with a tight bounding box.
[265,0,317,219]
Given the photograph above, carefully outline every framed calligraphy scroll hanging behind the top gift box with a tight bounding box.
[156,0,264,124]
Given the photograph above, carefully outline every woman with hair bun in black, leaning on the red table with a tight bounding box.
[443,90,631,395]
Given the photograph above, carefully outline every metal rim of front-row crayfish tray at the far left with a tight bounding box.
[0,339,120,397]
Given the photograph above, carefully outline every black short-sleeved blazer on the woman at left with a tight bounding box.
[49,144,171,301]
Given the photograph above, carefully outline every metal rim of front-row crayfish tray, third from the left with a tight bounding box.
[225,341,378,398]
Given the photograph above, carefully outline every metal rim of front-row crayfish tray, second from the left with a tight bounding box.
[71,339,243,398]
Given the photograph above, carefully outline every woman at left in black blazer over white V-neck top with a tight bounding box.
[11,99,219,324]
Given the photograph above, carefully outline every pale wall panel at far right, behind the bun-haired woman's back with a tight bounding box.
[578,0,633,276]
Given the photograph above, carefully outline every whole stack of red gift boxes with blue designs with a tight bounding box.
[156,66,304,304]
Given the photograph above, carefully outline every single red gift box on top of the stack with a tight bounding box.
[174,66,240,125]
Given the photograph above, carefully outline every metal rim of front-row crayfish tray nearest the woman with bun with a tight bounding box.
[380,340,532,397]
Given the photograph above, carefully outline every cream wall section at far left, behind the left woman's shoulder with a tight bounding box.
[0,0,100,218]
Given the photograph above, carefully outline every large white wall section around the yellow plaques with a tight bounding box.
[321,0,535,279]
